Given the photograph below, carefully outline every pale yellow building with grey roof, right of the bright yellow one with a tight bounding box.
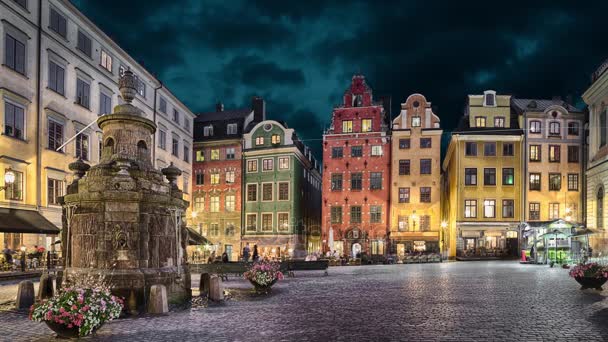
[511,98,586,224]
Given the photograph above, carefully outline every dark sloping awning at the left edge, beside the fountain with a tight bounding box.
[0,208,59,234]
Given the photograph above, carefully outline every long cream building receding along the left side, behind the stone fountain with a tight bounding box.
[0,0,194,248]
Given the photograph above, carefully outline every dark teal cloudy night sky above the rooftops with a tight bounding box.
[73,0,608,158]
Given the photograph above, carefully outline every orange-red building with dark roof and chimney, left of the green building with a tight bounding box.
[188,97,266,261]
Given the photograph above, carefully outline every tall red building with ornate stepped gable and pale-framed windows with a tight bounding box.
[322,75,391,257]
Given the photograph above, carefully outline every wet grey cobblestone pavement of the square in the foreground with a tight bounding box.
[0,262,608,342]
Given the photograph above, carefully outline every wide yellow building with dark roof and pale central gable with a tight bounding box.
[442,90,523,258]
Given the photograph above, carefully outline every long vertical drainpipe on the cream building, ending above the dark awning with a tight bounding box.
[35,0,42,210]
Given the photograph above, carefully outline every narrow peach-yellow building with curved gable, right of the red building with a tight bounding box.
[390,94,447,257]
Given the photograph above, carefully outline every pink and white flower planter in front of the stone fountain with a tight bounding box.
[30,276,123,338]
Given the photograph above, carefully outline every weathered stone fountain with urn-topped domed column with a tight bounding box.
[61,71,191,313]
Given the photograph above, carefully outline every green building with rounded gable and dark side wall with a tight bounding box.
[242,120,321,257]
